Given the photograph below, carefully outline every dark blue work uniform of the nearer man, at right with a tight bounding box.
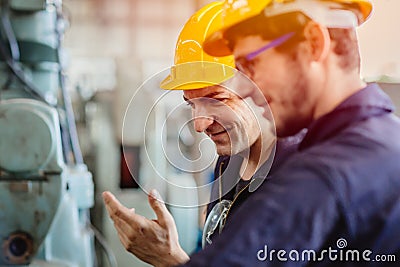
[184,84,400,267]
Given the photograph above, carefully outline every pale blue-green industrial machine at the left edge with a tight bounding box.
[0,0,95,267]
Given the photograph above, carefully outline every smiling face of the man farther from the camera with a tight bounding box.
[184,86,262,155]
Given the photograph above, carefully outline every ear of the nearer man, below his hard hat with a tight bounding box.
[304,21,331,61]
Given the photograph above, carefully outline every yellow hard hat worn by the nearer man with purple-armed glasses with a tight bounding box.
[204,0,372,56]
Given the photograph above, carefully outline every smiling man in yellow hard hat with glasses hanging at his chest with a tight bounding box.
[104,2,298,265]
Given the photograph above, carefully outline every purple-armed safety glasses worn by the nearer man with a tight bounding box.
[235,32,295,77]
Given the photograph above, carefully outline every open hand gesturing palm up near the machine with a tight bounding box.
[103,190,188,266]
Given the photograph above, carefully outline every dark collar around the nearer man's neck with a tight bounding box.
[299,83,394,150]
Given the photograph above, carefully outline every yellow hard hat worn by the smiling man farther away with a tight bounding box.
[160,2,235,90]
